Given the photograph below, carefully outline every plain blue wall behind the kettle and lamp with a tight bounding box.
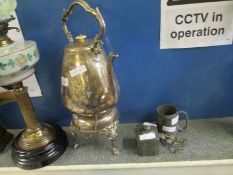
[0,0,233,128]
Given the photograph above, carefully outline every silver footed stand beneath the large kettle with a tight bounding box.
[70,107,119,155]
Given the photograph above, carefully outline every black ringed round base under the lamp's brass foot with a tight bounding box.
[12,125,68,170]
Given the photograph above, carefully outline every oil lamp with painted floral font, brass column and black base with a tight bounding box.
[0,0,67,169]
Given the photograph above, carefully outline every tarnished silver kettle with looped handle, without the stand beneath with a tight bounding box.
[62,0,118,117]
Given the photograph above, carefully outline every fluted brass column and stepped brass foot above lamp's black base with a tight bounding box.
[12,82,55,150]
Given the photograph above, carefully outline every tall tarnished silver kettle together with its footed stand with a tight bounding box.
[61,0,119,155]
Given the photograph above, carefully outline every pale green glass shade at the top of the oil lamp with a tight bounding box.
[0,0,17,20]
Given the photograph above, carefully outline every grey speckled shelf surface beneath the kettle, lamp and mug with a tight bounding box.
[0,117,233,167]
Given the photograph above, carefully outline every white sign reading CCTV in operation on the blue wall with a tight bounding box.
[160,0,233,49]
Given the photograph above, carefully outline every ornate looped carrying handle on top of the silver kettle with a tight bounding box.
[62,0,106,42]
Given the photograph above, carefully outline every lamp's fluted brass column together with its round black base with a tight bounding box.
[10,82,68,169]
